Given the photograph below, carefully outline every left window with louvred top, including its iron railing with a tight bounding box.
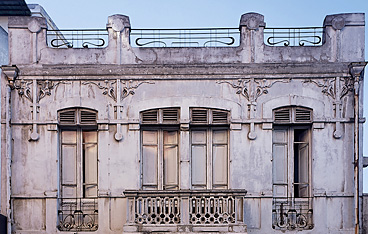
[58,108,98,232]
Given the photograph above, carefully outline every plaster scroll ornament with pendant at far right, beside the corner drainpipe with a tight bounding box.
[303,77,354,139]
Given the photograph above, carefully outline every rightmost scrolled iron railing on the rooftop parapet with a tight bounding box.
[264,27,324,46]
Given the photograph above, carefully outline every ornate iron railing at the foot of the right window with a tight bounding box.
[272,198,314,230]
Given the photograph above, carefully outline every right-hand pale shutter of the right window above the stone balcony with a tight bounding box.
[212,130,228,188]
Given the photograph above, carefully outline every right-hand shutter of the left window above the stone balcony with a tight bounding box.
[163,131,179,189]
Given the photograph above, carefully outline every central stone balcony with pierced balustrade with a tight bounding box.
[124,190,246,233]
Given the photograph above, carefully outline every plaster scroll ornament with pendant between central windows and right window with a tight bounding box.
[217,78,290,140]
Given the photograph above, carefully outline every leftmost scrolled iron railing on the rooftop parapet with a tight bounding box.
[47,29,108,48]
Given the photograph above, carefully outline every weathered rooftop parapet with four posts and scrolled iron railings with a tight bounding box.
[5,13,365,64]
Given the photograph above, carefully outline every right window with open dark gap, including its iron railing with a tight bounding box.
[272,107,314,230]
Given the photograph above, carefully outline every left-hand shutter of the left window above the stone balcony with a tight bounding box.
[142,131,158,188]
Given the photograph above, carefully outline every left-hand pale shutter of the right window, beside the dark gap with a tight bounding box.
[272,128,288,197]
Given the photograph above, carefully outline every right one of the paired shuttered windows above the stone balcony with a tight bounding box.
[190,108,229,189]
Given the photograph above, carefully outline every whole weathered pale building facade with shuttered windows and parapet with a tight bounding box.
[1,9,367,234]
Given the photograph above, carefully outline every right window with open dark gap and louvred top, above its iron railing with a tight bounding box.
[272,107,312,198]
